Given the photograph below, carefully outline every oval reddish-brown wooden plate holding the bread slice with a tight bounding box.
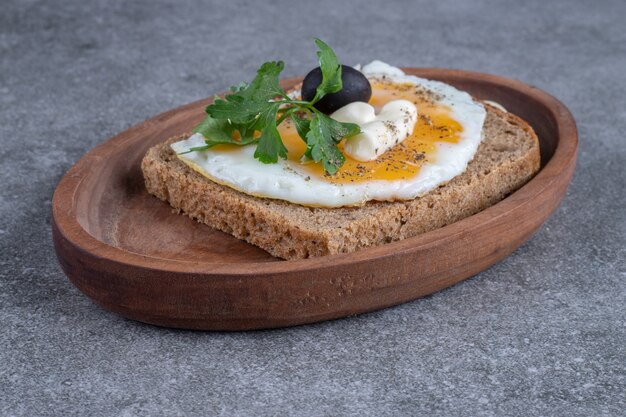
[52,68,578,330]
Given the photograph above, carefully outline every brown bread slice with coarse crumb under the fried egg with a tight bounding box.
[141,105,540,259]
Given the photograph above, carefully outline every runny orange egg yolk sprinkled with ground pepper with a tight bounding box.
[278,82,463,183]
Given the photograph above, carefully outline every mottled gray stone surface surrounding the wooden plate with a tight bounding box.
[0,0,626,416]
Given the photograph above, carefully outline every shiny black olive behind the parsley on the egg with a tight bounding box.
[302,65,372,114]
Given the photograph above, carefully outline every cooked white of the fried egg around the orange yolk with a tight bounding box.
[171,61,486,207]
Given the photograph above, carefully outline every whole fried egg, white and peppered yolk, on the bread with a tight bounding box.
[171,61,486,207]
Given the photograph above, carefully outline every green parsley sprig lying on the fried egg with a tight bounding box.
[183,39,360,174]
